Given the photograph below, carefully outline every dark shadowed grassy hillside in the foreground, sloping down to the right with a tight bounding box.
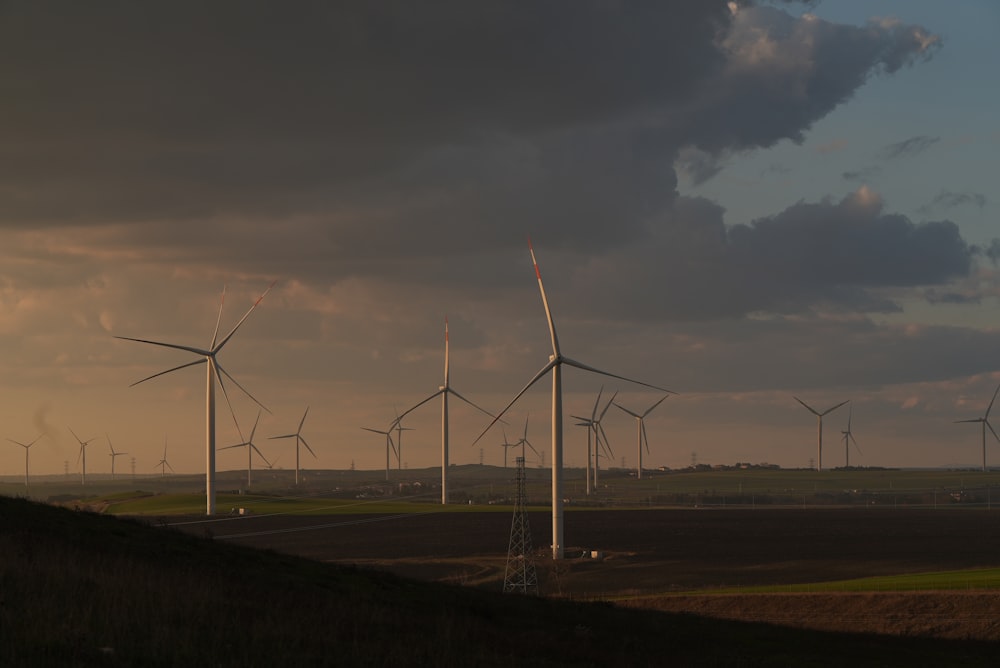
[0,498,996,666]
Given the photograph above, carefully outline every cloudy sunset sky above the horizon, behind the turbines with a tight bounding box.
[0,0,1000,475]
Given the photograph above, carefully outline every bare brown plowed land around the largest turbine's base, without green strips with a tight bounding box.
[181,508,1000,641]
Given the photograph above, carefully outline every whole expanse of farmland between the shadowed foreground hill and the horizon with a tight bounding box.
[11,466,1000,641]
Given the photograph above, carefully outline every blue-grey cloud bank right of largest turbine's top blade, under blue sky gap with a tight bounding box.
[577,188,978,320]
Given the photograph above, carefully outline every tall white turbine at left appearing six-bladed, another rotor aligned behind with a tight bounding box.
[115,281,277,515]
